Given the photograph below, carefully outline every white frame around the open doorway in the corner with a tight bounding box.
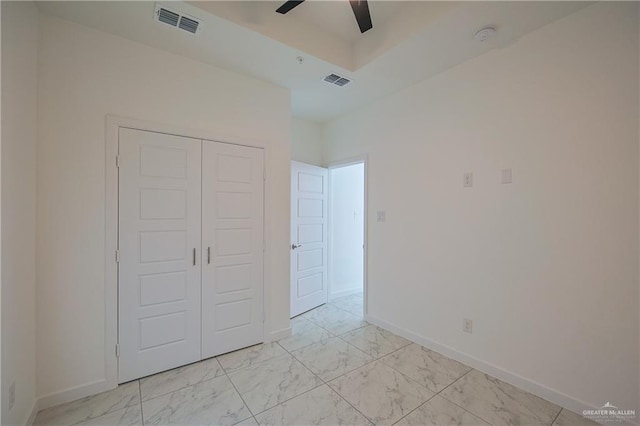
[327,153,369,319]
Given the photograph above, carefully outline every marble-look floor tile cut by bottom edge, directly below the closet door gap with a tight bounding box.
[142,376,251,426]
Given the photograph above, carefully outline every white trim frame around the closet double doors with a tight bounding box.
[107,114,273,388]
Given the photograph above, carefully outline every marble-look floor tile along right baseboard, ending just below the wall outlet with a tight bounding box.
[382,343,471,392]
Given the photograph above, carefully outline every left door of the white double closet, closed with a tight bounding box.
[118,128,201,383]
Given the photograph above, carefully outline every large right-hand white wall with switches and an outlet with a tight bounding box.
[325,2,640,410]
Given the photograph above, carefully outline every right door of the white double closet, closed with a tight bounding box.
[202,141,264,358]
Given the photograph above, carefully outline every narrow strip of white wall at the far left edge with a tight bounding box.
[1,2,38,425]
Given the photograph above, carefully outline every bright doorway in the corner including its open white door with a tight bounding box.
[290,159,366,321]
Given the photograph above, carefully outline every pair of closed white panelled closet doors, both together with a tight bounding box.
[118,128,264,383]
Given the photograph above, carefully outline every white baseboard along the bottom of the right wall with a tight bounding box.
[365,315,637,425]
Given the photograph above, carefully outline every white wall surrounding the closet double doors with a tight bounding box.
[37,16,291,401]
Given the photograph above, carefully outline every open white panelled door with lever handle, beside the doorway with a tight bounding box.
[291,161,329,317]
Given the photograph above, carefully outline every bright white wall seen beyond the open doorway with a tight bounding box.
[329,163,364,298]
